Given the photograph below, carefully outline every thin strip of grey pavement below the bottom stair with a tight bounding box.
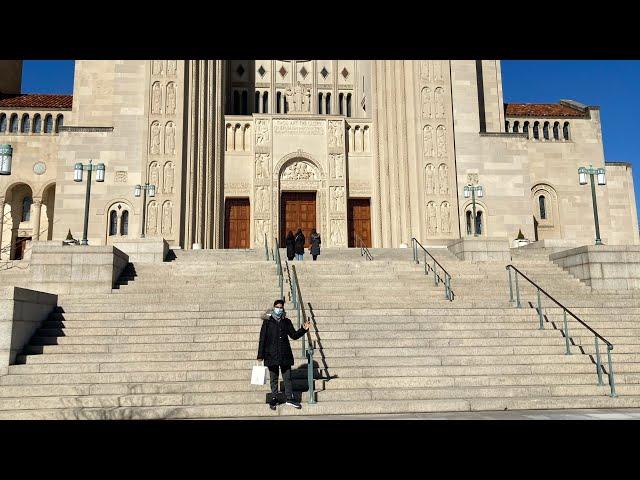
[234,405,640,420]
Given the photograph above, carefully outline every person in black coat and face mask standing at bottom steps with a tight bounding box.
[258,300,311,410]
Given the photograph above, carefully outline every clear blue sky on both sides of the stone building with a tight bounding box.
[22,60,640,215]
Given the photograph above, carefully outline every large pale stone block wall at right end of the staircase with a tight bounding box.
[549,245,640,291]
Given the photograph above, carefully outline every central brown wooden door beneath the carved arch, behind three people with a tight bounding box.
[280,192,322,247]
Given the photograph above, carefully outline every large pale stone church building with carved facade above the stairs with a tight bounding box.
[0,60,640,259]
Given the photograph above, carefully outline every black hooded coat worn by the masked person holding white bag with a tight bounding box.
[258,316,307,367]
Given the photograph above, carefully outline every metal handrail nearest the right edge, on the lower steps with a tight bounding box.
[506,265,618,397]
